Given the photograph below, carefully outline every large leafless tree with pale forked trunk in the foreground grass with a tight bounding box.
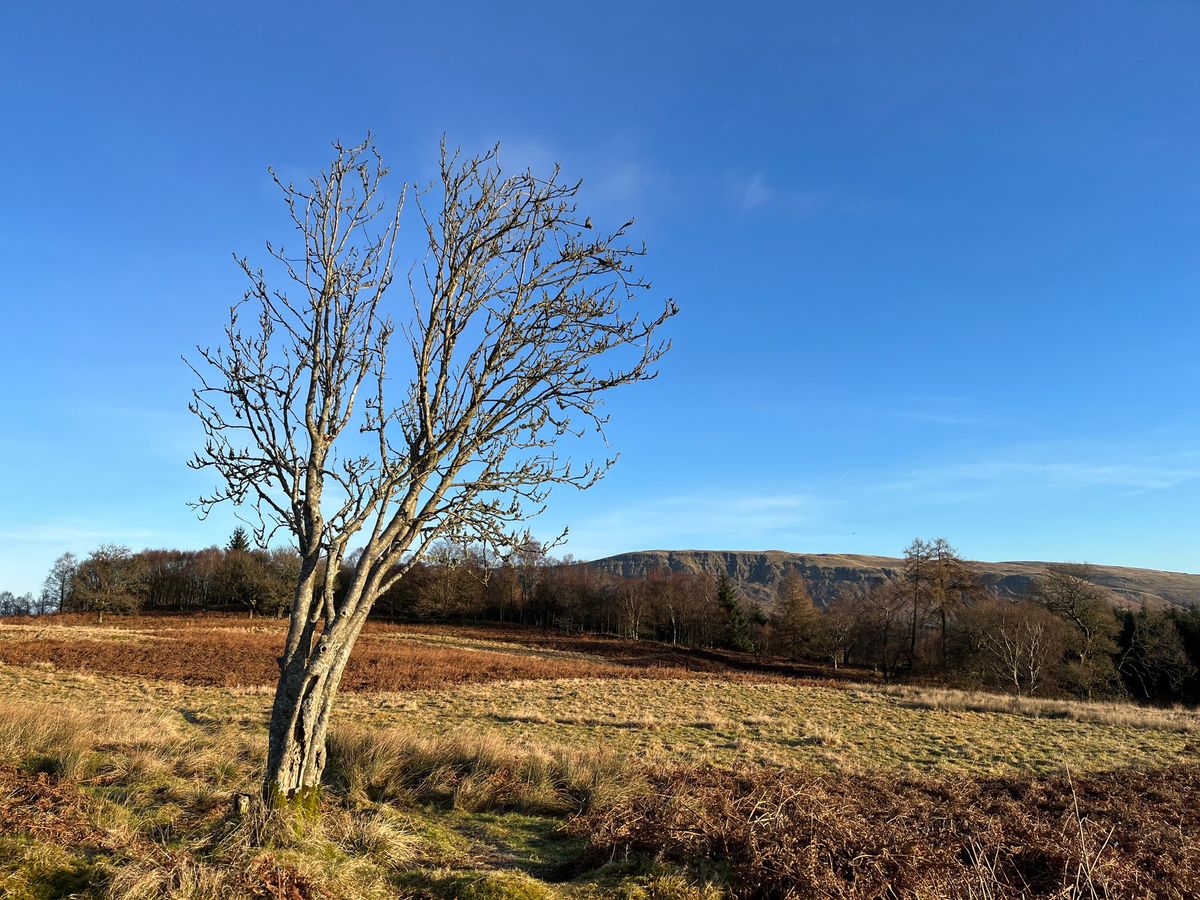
[191,138,676,806]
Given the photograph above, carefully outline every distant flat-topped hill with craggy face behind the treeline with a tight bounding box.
[590,550,1200,606]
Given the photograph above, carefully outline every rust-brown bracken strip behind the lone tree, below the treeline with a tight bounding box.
[0,613,849,691]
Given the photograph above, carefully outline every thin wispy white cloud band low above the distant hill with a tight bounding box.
[559,441,1200,558]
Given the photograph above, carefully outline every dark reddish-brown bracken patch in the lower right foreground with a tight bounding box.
[572,766,1200,900]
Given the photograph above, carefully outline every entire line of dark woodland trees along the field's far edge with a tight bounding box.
[16,529,1200,702]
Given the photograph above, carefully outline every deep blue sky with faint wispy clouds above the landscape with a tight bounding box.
[0,0,1200,600]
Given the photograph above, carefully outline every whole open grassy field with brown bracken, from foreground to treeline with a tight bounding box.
[0,618,1200,898]
